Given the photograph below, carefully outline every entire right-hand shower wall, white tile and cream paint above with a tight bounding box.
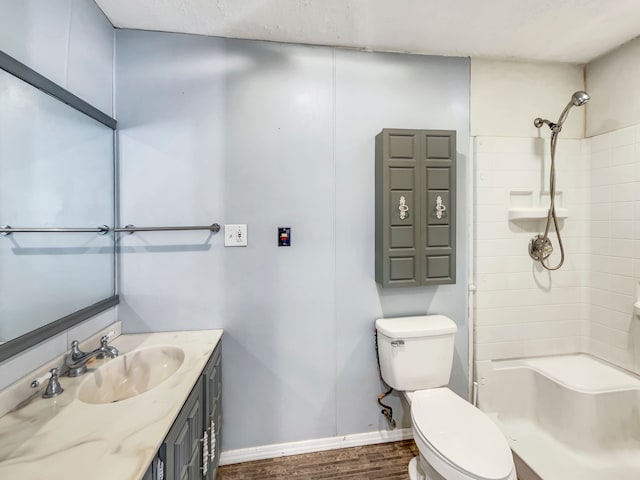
[585,39,640,373]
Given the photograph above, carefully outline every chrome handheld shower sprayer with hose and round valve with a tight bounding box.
[529,90,591,270]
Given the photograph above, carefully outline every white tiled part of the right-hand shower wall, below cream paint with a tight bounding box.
[588,126,640,373]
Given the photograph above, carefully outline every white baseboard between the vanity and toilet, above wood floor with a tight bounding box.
[220,428,413,465]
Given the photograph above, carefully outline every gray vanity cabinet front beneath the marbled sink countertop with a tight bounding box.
[155,345,222,480]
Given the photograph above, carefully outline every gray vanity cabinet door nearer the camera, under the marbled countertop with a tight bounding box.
[165,376,205,480]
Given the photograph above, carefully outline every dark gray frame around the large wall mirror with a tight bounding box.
[0,50,120,362]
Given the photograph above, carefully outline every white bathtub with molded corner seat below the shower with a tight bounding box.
[477,354,640,480]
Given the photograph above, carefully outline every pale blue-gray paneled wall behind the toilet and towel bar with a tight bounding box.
[116,30,469,450]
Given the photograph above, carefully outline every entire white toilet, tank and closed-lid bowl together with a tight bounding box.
[376,315,517,480]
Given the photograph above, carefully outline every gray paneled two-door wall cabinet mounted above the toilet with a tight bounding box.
[375,128,456,287]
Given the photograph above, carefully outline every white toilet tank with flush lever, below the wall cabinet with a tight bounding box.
[376,315,457,391]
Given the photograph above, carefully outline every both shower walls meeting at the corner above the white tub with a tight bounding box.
[471,53,640,373]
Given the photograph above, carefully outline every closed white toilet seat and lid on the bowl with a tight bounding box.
[411,388,516,480]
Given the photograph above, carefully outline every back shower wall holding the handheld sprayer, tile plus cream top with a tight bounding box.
[471,59,590,361]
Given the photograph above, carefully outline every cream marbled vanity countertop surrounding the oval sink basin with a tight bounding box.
[0,330,222,480]
